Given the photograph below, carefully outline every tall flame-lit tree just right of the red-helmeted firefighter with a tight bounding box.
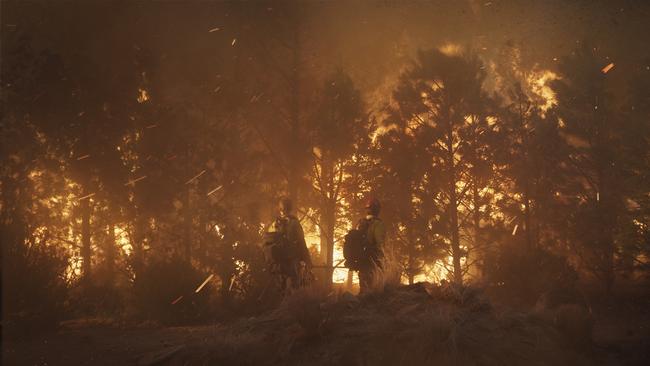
[389,50,496,283]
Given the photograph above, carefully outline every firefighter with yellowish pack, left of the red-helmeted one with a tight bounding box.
[264,197,311,292]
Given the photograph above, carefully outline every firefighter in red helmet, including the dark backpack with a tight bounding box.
[343,198,386,293]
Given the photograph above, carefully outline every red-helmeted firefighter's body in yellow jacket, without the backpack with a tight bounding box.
[357,198,386,293]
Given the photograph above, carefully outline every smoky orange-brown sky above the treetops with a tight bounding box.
[2,0,650,105]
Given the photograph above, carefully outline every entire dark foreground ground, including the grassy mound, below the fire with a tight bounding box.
[2,285,650,366]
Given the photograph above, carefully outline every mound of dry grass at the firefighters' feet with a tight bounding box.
[171,282,593,365]
